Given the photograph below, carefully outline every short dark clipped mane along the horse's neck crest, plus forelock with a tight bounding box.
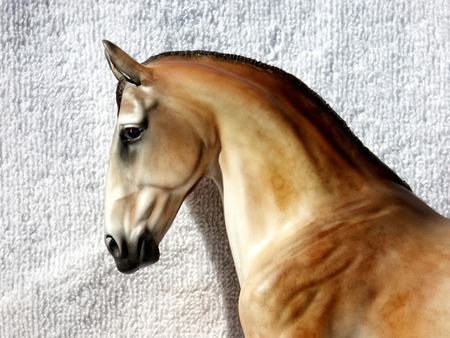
[136,50,411,191]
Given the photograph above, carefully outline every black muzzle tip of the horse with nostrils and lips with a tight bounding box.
[105,233,159,273]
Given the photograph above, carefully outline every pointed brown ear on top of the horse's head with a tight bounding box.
[103,40,146,86]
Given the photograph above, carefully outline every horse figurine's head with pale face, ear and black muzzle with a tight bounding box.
[104,41,221,273]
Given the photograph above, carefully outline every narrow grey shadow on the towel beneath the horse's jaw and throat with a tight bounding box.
[186,178,244,338]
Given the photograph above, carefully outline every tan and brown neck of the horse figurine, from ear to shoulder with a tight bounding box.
[148,58,412,281]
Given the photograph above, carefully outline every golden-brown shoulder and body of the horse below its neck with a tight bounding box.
[239,210,450,337]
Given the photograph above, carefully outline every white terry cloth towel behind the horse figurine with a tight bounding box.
[0,0,450,337]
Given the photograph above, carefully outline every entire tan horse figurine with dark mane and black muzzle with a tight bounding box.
[104,41,450,338]
